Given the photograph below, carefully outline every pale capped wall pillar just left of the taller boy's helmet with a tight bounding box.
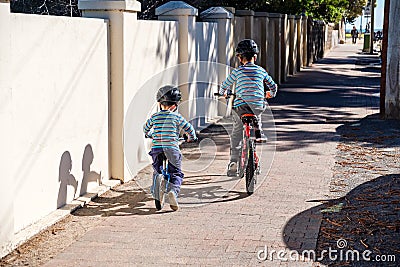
[200,7,235,116]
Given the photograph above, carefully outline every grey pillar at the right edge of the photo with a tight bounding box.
[385,1,400,119]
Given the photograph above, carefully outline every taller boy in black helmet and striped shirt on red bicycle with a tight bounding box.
[219,39,278,176]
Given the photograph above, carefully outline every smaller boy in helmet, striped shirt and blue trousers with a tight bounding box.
[143,86,197,211]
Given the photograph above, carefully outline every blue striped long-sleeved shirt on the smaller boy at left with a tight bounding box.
[143,110,196,150]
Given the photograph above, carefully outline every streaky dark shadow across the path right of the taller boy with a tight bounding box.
[270,52,380,151]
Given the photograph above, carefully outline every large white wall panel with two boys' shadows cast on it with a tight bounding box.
[0,6,108,255]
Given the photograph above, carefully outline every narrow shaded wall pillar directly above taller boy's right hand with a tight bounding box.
[267,13,282,84]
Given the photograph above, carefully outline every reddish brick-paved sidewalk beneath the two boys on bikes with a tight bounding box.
[42,45,379,266]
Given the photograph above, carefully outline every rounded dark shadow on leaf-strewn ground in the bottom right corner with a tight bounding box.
[283,174,400,266]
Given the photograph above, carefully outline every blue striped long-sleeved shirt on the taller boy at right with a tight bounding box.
[219,62,277,108]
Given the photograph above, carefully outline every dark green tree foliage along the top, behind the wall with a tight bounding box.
[11,0,367,22]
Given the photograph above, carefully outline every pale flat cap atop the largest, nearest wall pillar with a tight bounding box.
[78,0,142,12]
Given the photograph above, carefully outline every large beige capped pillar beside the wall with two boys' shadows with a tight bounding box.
[78,0,141,181]
